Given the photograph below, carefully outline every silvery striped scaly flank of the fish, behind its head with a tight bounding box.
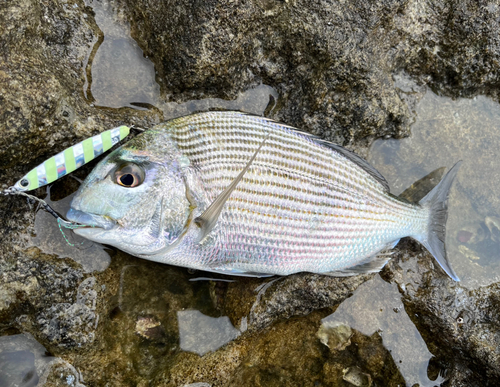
[165,112,428,274]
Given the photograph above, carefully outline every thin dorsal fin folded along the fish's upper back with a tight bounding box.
[241,113,390,192]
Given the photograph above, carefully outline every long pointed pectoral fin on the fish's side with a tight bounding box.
[194,137,267,240]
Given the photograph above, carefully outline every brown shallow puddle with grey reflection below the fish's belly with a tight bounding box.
[104,264,241,366]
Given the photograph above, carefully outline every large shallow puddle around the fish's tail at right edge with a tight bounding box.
[369,82,500,288]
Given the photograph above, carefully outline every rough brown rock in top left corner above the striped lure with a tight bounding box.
[0,0,158,171]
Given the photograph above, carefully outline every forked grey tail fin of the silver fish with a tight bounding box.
[417,161,462,281]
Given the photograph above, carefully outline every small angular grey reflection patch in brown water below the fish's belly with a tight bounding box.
[177,310,240,356]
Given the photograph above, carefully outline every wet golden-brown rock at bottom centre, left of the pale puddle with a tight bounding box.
[154,309,404,387]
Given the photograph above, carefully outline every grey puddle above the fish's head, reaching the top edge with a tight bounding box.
[84,0,278,115]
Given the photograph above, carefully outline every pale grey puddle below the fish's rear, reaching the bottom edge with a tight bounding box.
[322,276,444,387]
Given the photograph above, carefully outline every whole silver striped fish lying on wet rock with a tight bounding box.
[67,111,461,281]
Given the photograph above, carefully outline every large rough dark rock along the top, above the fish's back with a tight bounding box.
[117,0,500,144]
